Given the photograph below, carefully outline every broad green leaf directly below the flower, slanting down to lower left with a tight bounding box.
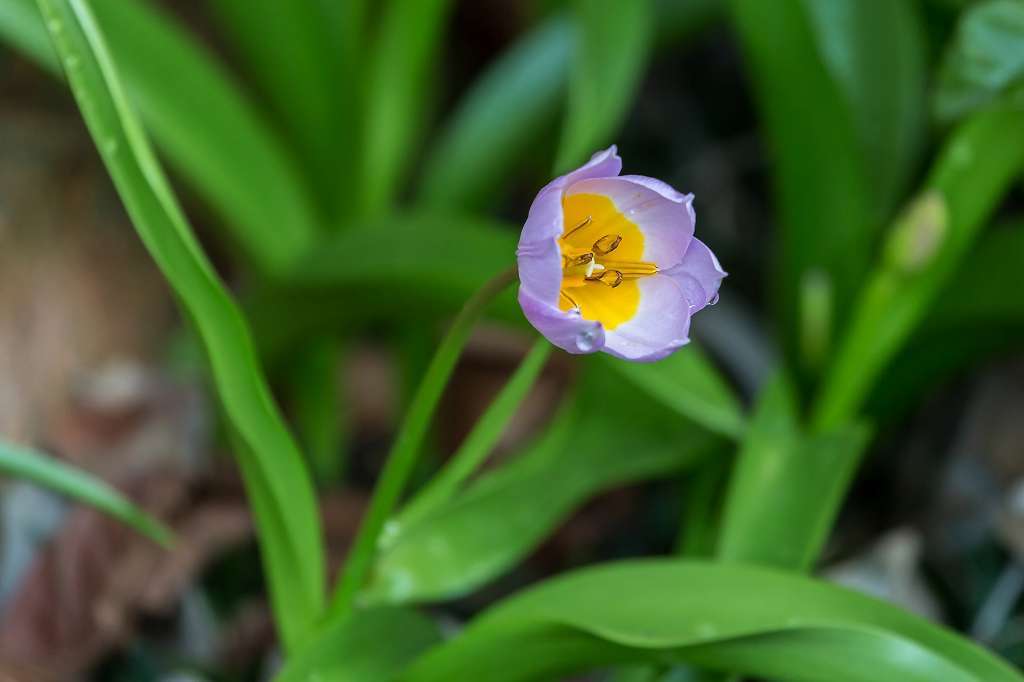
[364,371,715,606]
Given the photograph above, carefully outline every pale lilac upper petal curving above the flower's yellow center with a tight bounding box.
[565,177,694,268]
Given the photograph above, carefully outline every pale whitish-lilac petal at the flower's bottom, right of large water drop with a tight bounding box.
[604,274,690,363]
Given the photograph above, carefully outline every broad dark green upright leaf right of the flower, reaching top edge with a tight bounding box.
[730,0,924,374]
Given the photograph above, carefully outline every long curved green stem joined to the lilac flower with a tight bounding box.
[329,267,516,617]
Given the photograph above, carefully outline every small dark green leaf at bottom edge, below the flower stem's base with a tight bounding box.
[274,608,441,682]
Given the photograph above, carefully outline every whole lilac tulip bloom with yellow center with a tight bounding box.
[516,146,726,361]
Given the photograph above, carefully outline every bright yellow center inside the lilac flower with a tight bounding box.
[558,195,657,330]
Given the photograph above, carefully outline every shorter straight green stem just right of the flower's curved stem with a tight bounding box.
[399,337,551,526]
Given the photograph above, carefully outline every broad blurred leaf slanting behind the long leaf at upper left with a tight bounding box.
[0,0,318,274]
